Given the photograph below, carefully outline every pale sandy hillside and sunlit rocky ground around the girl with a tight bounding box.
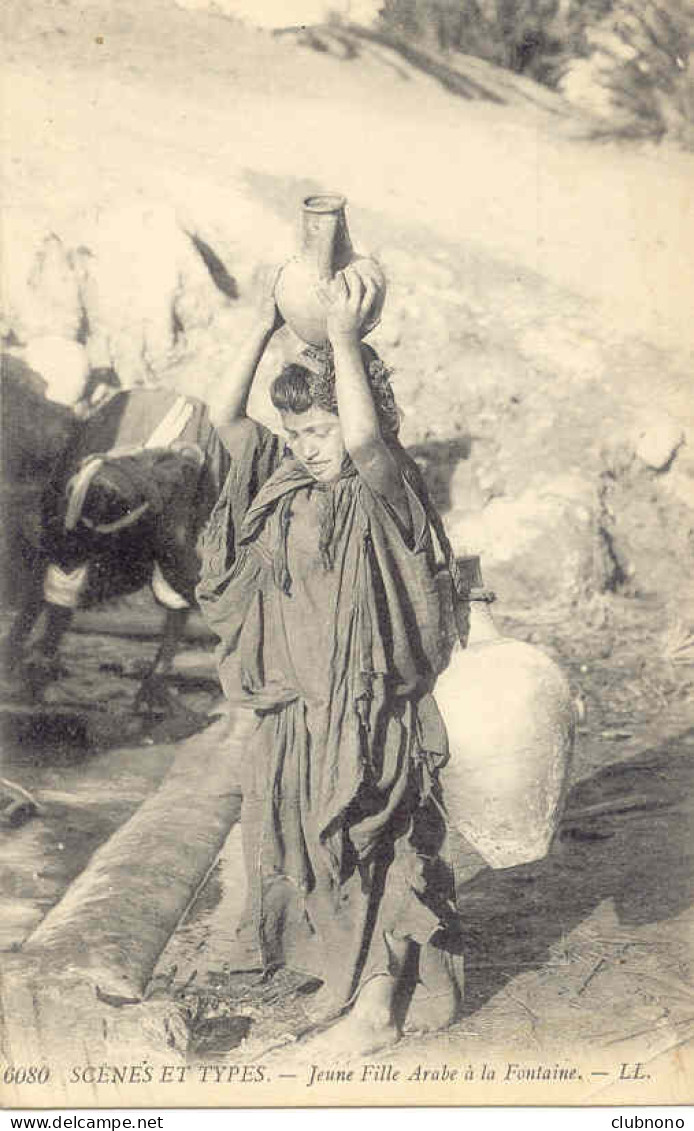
[1,0,694,1108]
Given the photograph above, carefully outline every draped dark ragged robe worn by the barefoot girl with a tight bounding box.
[198,421,463,1009]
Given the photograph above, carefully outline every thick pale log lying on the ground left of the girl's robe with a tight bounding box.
[23,711,257,1002]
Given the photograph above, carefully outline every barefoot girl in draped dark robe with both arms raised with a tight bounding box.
[198,269,459,1053]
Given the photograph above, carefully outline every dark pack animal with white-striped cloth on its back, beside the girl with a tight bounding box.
[7,389,229,701]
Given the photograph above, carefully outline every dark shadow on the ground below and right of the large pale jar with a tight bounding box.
[456,731,694,1016]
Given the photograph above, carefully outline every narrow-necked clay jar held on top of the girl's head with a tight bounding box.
[275,193,385,346]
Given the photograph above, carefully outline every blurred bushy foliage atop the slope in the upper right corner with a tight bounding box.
[380,0,694,145]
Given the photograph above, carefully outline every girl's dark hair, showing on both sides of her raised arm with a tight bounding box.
[270,344,400,438]
